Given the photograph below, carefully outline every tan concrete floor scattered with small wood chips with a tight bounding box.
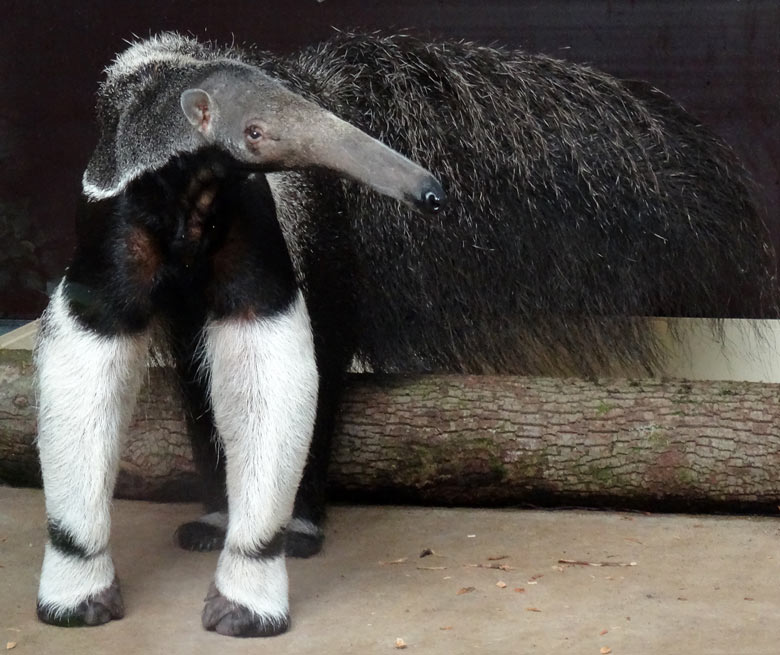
[0,488,780,655]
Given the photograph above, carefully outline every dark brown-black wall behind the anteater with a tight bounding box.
[0,0,780,318]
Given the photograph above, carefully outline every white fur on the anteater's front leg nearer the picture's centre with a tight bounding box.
[204,293,317,618]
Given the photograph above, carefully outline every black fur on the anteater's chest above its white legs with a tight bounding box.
[61,149,297,334]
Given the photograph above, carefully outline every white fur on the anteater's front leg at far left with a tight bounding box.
[35,283,148,612]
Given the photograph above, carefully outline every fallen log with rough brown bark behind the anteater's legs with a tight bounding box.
[0,350,780,509]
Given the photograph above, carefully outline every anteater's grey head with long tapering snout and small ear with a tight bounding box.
[181,64,444,214]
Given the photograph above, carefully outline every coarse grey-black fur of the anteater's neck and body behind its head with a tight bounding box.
[94,34,776,373]
